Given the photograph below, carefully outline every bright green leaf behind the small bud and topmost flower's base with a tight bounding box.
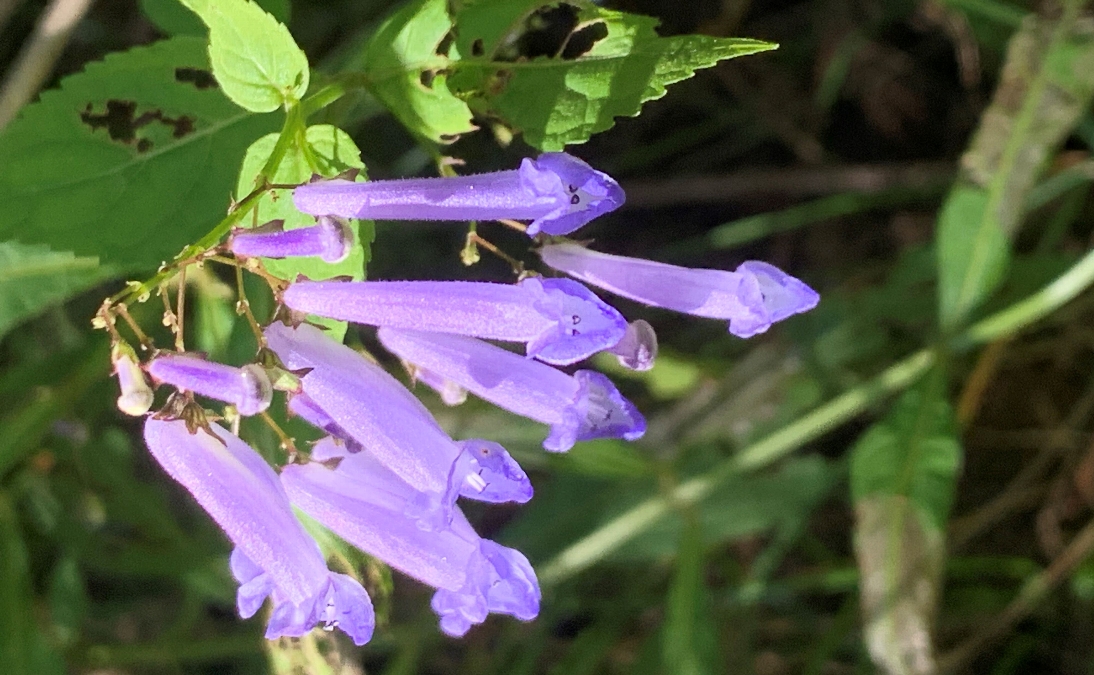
[238,125,375,335]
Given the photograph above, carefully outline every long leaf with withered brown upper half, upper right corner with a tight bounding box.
[938,9,1094,329]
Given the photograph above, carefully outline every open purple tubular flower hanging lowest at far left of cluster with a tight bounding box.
[144,418,374,644]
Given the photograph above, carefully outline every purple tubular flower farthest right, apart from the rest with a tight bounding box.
[539,244,821,338]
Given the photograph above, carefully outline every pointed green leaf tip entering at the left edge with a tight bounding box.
[0,242,110,337]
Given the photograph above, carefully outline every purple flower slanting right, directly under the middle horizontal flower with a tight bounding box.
[377,328,645,452]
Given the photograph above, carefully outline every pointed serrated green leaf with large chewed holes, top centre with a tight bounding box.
[447,0,776,150]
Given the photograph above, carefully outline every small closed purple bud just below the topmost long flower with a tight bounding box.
[228,216,353,265]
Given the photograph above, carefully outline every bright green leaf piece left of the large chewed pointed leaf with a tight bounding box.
[364,0,476,142]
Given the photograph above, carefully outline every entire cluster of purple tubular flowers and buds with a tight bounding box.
[114,153,818,644]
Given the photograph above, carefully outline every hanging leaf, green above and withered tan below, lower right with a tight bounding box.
[850,371,962,675]
